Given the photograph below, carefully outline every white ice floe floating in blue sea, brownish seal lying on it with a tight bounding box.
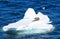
[3,8,54,34]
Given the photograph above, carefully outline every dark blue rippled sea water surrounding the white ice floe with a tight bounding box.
[0,0,60,39]
